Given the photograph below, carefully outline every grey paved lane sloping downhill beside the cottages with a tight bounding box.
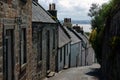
[44,64,100,80]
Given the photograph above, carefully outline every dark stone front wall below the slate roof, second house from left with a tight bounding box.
[32,22,58,80]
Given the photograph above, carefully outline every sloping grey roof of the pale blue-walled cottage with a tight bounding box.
[64,27,81,44]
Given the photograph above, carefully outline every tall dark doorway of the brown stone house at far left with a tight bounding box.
[4,29,14,80]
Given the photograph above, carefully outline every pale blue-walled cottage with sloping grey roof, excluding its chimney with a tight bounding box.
[64,26,82,67]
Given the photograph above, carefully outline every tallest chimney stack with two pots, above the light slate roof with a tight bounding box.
[48,3,57,20]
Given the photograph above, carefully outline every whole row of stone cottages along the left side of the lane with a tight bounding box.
[0,0,93,80]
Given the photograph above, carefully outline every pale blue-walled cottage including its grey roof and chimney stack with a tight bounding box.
[63,18,82,67]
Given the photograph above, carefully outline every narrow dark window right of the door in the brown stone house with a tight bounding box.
[20,28,27,67]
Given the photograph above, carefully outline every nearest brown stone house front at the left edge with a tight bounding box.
[0,0,34,80]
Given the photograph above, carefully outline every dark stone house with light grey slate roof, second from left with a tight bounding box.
[32,0,58,80]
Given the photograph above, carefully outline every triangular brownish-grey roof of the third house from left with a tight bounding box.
[58,26,71,48]
